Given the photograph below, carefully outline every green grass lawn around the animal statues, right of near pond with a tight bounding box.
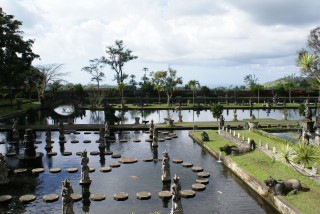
[196,131,320,214]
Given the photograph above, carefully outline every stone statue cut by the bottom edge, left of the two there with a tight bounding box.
[61,178,74,214]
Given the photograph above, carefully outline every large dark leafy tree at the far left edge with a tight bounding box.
[0,10,39,102]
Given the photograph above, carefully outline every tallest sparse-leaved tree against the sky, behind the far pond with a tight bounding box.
[101,40,138,84]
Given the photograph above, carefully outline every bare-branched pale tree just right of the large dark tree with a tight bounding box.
[36,64,67,98]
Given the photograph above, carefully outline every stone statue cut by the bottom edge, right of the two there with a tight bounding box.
[171,175,183,214]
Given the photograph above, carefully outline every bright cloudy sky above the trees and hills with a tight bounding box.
[0,0,320,86]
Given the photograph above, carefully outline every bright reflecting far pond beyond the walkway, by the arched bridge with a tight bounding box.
[0,106,317,125]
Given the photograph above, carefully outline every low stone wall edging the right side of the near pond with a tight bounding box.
[189,131,302,214]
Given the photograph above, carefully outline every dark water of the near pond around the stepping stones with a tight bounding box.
[0,131,277,214]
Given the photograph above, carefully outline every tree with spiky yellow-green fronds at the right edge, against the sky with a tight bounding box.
[297,27,320,82]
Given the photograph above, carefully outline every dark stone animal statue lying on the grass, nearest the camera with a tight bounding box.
[264,176,302,195]
